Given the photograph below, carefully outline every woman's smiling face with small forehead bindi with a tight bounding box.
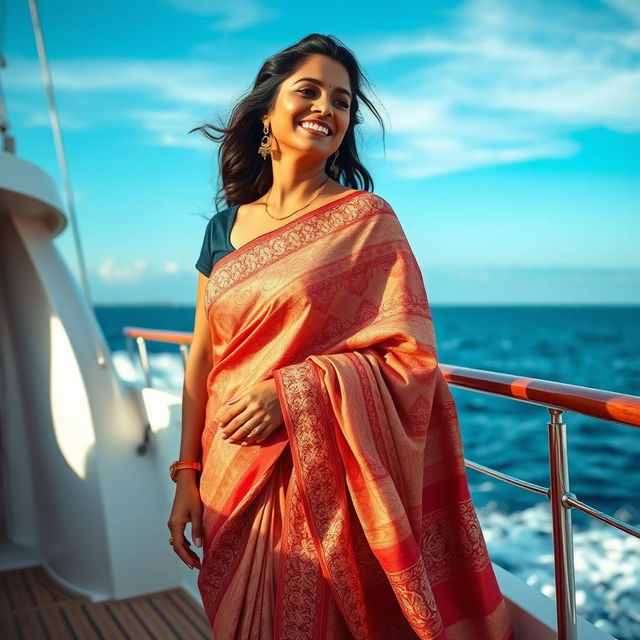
[263,54,351,161]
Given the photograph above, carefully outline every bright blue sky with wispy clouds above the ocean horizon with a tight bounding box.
[2,0,640,305]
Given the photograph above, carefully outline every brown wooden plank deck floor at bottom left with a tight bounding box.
[0,566,212,640]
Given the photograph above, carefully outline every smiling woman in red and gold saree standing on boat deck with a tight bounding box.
[168,34,513,640]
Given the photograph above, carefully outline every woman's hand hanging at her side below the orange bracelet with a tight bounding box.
[167,476,202,569]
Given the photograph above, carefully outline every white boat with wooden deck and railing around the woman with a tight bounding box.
[0,2,640,640]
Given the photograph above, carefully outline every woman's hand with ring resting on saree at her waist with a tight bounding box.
[214,378,283,444]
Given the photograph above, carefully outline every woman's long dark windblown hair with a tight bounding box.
[189,33,384,208]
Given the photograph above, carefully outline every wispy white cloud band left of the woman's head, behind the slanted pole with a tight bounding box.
[6,58,239,152]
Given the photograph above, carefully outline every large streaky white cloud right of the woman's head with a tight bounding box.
[354,0,640,179]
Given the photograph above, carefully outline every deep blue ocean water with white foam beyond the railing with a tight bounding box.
[96,306,640,640]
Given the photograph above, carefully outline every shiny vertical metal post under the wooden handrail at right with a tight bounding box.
[547,407,578,640]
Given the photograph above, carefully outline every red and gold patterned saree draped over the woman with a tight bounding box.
[198,191,514,640]
